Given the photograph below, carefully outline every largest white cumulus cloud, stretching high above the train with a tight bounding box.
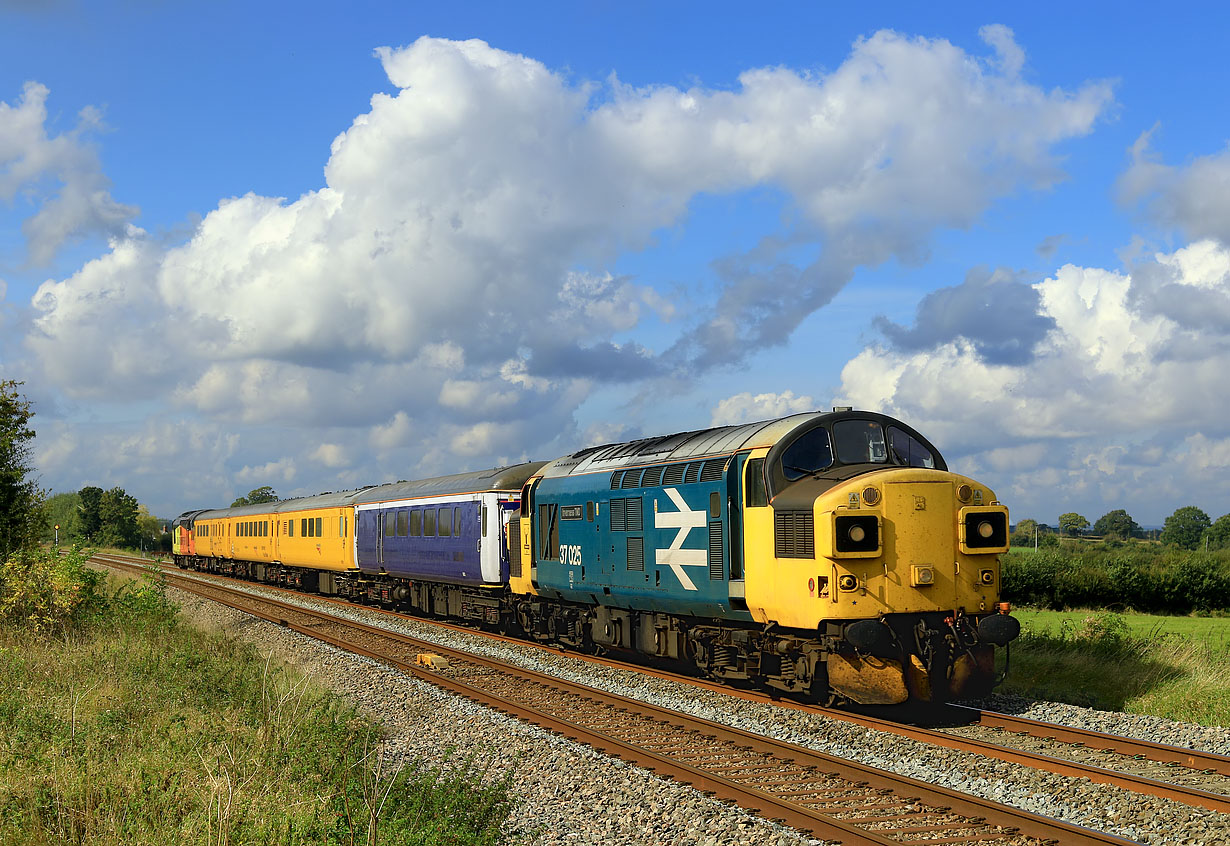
[16,27,1111,509]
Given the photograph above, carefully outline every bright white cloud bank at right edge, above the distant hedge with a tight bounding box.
[841,241,1230,521]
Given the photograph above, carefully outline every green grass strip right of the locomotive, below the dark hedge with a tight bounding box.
[999,609,1230,725]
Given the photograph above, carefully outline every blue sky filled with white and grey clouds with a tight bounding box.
[0,0,1230,525]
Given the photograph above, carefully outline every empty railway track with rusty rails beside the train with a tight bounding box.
[101,558,1151,846]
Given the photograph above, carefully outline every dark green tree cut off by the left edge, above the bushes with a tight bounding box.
[0,380,43,562]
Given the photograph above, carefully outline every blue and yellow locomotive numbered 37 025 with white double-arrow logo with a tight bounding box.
[509,409,1020,705]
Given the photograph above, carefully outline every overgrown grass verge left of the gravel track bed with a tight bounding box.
[0,545,509,846]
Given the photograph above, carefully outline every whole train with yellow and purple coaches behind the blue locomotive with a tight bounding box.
[175,408,1020,705]
